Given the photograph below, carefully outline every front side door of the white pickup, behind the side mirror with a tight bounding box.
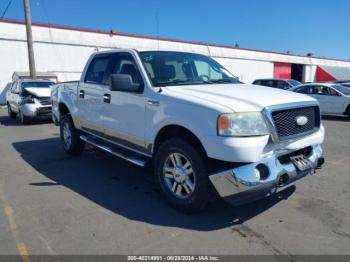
[103,52,146,153]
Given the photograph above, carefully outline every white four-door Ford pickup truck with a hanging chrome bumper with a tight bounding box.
[51,49,324,212]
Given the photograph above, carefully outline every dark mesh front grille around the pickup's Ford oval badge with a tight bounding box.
[272,106,320,140]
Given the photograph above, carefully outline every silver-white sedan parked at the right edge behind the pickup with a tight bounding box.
[290,83,350,118]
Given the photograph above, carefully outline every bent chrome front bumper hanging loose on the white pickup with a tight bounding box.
[209,145,324,205]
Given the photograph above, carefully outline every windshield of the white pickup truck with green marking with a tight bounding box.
[140,51,240,87]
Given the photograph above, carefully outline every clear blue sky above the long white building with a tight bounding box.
[0,0,350,60]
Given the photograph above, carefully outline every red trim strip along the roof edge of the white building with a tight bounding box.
[0,18,350,62]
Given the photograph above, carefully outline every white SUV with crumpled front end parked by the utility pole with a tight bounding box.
[6,79,55,124]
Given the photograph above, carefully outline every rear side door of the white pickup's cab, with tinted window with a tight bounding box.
[77,54,110,136]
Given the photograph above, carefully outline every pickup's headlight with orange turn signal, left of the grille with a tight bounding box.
[218,112,269,136]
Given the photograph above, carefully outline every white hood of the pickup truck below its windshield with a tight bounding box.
[165,84,316,112]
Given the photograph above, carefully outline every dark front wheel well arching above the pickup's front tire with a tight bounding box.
[153,125,207,156]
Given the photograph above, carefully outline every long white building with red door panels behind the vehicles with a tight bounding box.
[0,19,350,103]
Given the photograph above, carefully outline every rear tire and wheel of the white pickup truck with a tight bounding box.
[60,115,85,155]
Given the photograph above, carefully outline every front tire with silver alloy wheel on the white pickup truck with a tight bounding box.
[155,138,212,213]
